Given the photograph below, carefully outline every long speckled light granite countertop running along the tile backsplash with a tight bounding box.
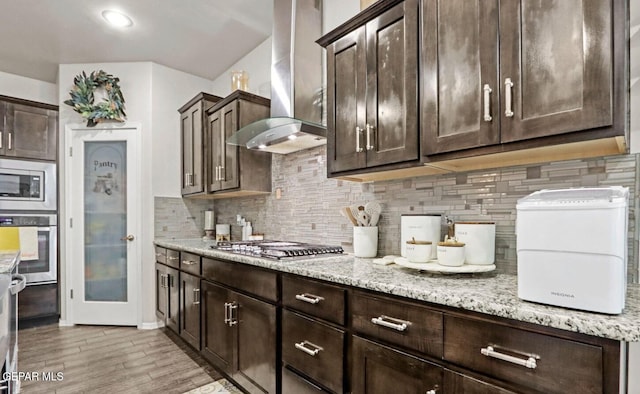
[155,239,640,342]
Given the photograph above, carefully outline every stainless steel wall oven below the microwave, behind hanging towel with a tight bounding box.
[0,213,58,285]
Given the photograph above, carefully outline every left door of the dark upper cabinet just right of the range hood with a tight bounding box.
[327,26,367,174]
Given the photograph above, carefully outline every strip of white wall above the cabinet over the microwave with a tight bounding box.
[0,71,58,105]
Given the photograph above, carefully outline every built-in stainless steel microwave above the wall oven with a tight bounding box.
[0,159,57,211]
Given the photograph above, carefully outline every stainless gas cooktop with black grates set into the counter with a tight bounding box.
[211,240,344,260]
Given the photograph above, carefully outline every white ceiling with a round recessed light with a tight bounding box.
[0,0,273,82]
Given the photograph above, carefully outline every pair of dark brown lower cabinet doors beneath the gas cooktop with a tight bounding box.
[202,281,278,393]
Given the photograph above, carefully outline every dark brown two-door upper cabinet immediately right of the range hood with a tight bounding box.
[318,0,420,177]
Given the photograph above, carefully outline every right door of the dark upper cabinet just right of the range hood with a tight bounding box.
[364,0,419,167]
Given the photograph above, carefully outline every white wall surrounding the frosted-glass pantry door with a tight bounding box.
[58,62,211,327]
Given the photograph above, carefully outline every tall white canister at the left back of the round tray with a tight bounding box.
[400,214,442,259]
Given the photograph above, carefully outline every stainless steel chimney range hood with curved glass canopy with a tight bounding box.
[227,0,327,154]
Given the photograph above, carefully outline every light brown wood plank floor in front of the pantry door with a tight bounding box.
[18,325,221,394]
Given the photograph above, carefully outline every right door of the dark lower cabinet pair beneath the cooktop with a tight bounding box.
[231,292,277,393]
